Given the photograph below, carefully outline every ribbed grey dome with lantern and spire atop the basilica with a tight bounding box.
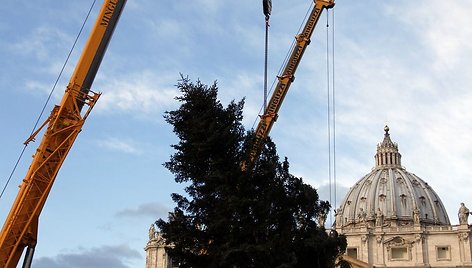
[336,126,450,228]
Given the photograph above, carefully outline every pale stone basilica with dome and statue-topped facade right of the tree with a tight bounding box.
[334,127,472,267]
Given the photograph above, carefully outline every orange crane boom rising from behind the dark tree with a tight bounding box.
[242,0,334,170]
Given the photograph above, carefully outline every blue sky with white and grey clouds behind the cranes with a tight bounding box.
[0,0,472,268]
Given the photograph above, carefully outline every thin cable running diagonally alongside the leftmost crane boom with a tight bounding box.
[0,0,96,199]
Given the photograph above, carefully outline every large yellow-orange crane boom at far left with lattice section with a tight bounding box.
[0,0,126,268]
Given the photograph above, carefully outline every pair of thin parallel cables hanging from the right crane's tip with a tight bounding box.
[326,7,337,226]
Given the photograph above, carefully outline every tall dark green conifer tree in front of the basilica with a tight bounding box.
[156,77,346,268]
